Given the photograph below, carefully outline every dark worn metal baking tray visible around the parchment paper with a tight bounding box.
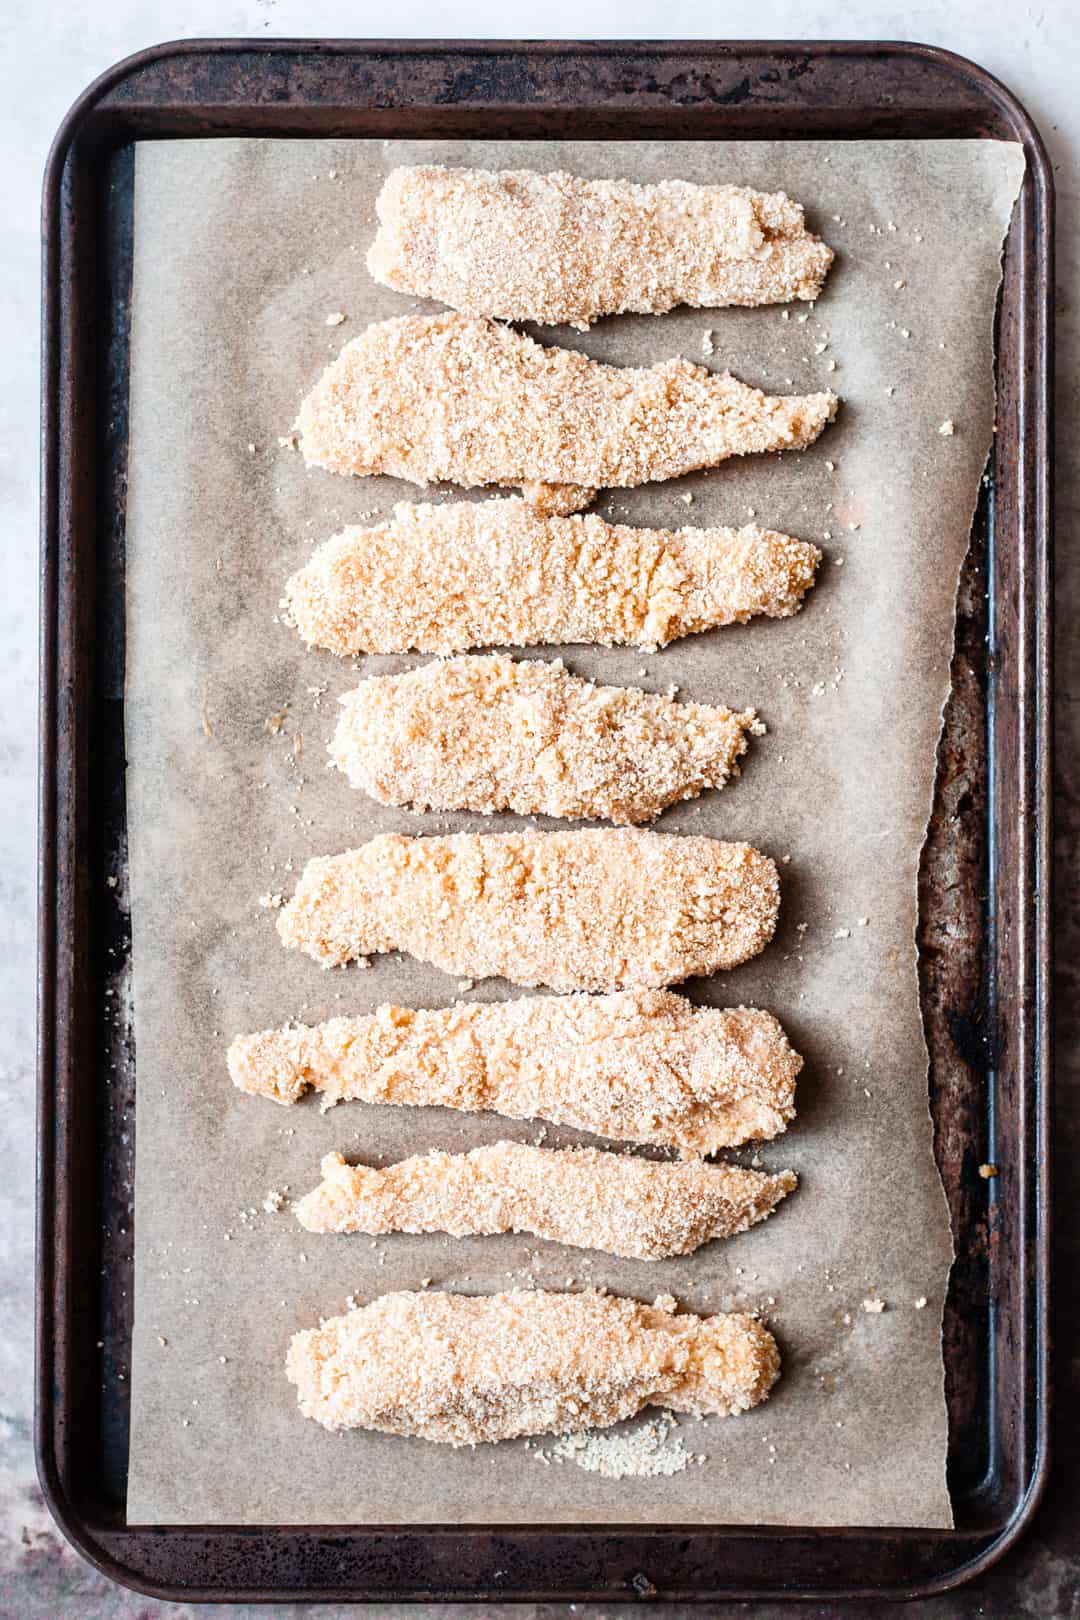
[36,41,1052,1604]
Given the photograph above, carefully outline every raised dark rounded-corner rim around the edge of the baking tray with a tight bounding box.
[34,37,1054,1602]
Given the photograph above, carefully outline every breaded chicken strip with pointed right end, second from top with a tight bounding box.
[296,314,837,498]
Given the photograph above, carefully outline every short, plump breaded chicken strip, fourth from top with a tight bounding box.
[330,656,764,825]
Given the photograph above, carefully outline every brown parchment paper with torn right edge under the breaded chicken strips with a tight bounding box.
[126,132,1023,1526]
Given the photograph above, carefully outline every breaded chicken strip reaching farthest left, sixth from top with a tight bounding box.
[228,990,803,1158]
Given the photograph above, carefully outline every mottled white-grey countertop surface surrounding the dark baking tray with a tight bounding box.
[0,0,1080,1620]
